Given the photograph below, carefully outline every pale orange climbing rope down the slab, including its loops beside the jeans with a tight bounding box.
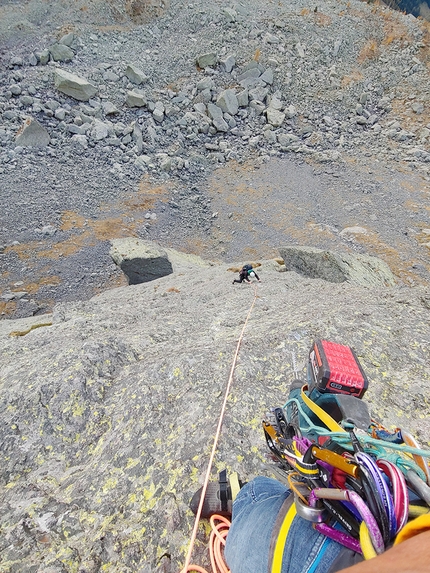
[181,286,258,573]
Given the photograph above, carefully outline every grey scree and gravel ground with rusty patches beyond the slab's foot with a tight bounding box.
[0,0,430,318]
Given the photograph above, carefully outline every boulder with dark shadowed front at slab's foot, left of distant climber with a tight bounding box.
[110,238,173,285]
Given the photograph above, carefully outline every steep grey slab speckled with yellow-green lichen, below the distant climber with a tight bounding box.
[0,261,430,573]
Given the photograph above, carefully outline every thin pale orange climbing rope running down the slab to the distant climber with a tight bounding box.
[181,285,258,573]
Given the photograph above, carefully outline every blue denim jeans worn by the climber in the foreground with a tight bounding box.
[224,477,361,573]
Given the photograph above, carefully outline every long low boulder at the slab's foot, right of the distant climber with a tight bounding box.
[279,246,396,287]
